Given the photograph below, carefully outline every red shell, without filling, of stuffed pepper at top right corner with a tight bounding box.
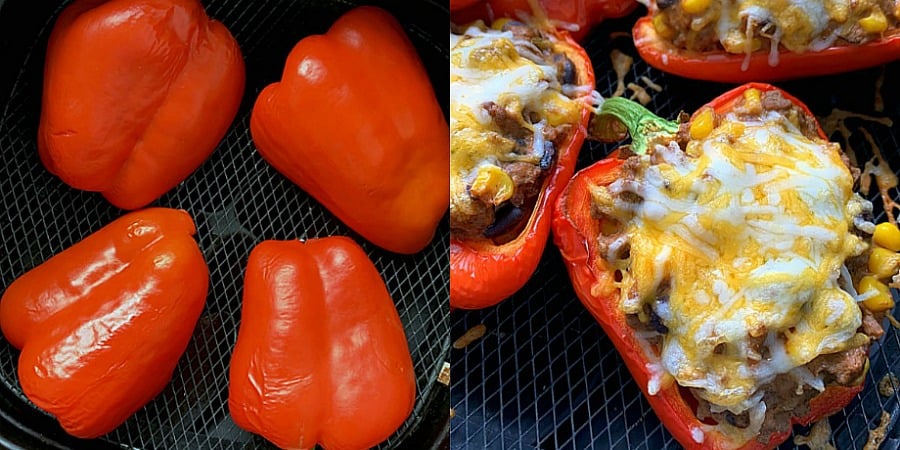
[632,2,900,83]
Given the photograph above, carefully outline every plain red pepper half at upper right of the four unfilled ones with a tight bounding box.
[250,6,450,254]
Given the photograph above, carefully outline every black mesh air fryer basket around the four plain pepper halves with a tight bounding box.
[0,0,449,449]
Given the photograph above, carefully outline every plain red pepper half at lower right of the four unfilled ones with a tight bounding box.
[228,237,416,450]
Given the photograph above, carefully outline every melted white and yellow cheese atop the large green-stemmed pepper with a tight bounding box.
[608,112,867,413]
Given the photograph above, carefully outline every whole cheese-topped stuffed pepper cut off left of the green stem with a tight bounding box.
[450,14,594,309]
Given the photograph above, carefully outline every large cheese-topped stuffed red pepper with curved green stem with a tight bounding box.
[553,84,900,449]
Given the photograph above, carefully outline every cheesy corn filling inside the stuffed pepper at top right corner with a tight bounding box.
[653,0,900,70]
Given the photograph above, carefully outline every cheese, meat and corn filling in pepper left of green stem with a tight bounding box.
[450,21,593,243]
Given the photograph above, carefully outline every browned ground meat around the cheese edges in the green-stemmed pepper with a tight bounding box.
[592,91,884,444]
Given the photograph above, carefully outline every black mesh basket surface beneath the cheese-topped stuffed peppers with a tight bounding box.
[450,12,900,450]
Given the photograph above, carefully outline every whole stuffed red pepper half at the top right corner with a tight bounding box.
[633,0,900,83]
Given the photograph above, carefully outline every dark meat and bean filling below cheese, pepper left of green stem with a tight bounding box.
[450,21,578,244]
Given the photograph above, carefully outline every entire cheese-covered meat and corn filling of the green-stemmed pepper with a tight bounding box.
[592,89,896,443]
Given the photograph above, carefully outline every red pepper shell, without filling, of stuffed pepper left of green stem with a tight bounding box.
[450,19,594,309]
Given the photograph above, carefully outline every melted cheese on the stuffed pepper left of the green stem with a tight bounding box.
[450,22,592,229]
